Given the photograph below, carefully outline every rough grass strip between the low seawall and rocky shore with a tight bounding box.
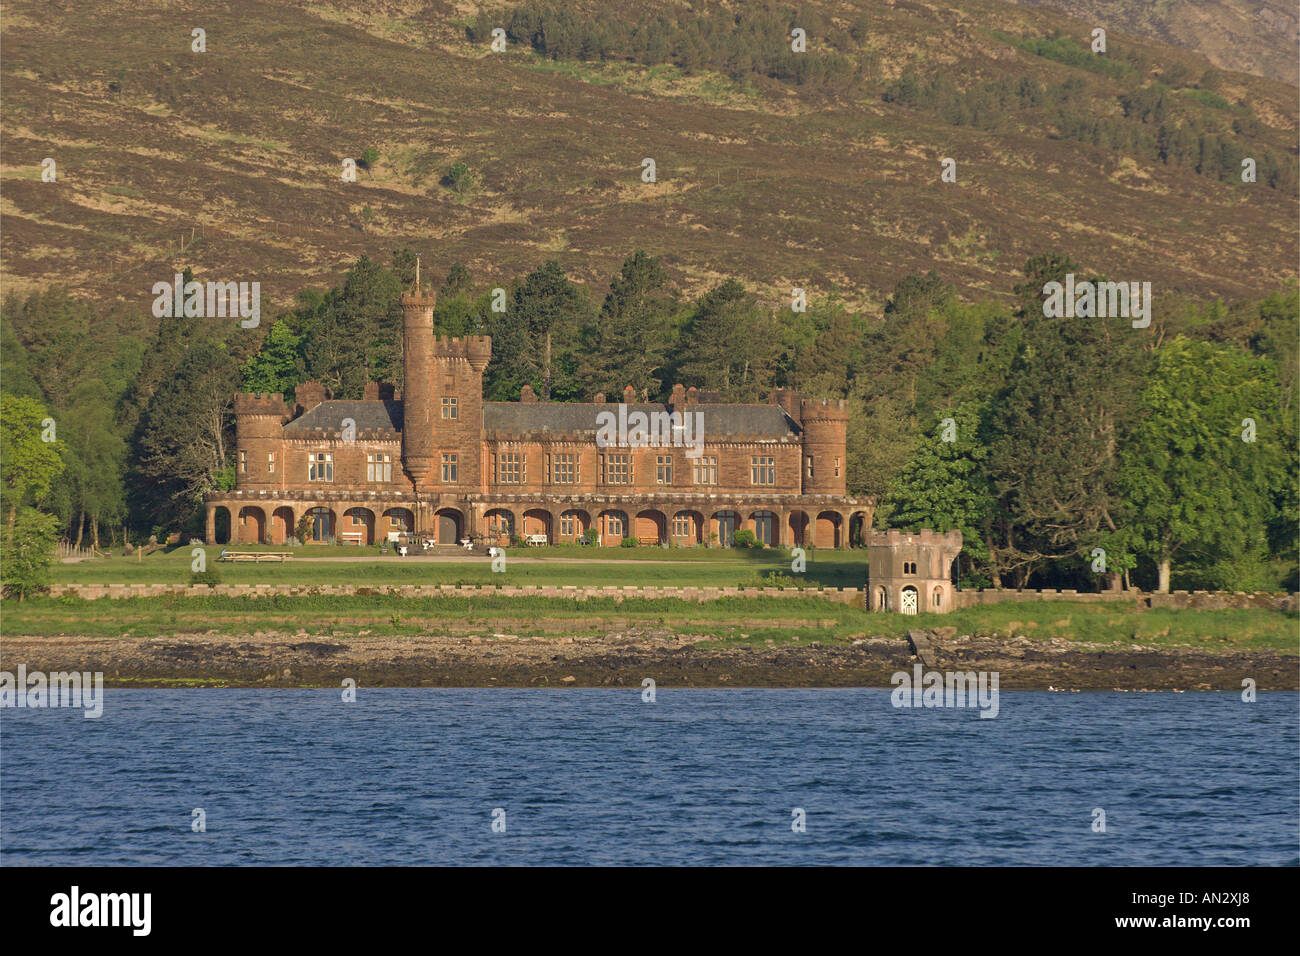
[3,596,1297,653]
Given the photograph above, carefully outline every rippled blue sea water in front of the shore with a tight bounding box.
[0,687,1300,865]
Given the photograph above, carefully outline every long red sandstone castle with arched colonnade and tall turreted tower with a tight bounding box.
[205,283,874,548]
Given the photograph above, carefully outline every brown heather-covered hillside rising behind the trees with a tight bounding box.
[0,0,1300,311]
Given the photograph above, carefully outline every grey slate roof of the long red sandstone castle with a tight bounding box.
[285,399,798,441]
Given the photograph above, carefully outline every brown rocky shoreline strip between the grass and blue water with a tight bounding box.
[0,627,1300,691]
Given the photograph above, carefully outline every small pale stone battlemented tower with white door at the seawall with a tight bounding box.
[867,528,962,614]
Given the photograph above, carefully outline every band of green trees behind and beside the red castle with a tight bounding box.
[0,248,1300,598]
